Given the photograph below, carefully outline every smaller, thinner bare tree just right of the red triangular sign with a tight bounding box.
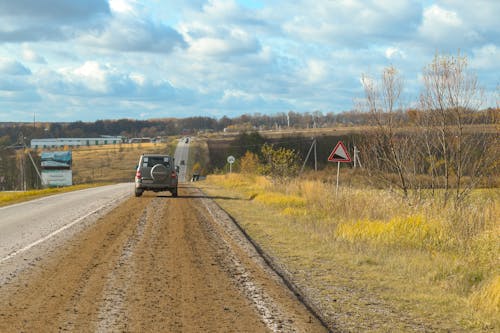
[361,66,411,197]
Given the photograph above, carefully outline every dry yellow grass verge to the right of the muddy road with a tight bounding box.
[200,173,500,332]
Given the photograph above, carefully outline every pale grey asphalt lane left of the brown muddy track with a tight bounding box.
[0,183,134,263]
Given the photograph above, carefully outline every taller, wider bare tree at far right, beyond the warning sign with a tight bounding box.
[420,54,498,204]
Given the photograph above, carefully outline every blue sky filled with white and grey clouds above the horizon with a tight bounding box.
[0,0,500,122]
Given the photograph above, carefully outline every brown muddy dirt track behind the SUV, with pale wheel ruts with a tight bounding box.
[0,188,326,332]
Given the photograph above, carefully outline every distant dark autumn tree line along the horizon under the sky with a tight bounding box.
[0,108,498,147]
